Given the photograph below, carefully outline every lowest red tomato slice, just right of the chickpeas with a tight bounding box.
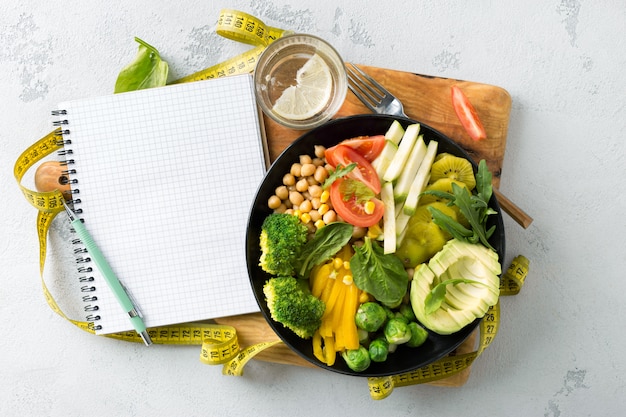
[330,178,385,227]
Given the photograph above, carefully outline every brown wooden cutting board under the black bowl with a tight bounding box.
[215,65,511,386]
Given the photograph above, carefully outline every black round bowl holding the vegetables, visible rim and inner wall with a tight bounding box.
[246,115,505,377]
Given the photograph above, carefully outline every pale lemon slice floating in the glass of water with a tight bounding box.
[272,54,333,120]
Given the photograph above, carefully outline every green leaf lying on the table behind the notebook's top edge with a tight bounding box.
[114,38,169,93]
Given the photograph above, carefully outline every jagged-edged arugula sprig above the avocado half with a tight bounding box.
[422,159,497,249]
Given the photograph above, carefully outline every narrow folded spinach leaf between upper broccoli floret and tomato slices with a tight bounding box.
[295,222,354,279]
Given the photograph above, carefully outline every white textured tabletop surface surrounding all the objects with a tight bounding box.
[0,0,626,417]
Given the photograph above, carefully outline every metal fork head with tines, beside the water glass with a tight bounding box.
[346,64,407,117]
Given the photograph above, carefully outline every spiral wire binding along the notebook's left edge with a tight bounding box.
[52,110,102,330]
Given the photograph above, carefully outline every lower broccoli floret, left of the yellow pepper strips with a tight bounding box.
[263,277,326,339]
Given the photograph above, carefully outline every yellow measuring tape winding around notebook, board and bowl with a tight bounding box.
[13,9,528,399]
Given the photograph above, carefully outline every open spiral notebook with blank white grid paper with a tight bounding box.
[53,74,267,334]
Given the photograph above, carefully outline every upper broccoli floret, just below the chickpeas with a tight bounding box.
[259,213,308,276]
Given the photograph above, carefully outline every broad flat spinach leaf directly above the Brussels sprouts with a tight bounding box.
[350,237,409,306]
